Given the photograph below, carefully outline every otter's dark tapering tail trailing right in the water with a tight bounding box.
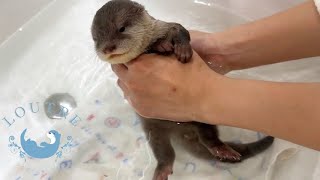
[226,136,274,160]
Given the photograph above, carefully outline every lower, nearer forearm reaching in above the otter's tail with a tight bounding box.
[200,78,320,150]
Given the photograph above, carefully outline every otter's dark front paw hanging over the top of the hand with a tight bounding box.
[174,43,193,63]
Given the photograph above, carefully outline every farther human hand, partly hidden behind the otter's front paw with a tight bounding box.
[189,30,232,74]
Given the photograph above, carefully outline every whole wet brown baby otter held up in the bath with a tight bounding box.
[91,0,274,180]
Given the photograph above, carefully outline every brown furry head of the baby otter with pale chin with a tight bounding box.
[91,0,150,64]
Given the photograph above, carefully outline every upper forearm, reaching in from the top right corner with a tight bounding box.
[212,1,320,70]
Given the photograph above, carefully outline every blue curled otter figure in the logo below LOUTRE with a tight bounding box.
[20,129,61,159]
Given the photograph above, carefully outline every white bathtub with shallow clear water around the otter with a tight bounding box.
[0,0,320,180]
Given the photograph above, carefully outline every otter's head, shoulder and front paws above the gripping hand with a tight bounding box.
[91,0,192,64]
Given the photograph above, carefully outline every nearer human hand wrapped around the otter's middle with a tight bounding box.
[112,52,224,121]
